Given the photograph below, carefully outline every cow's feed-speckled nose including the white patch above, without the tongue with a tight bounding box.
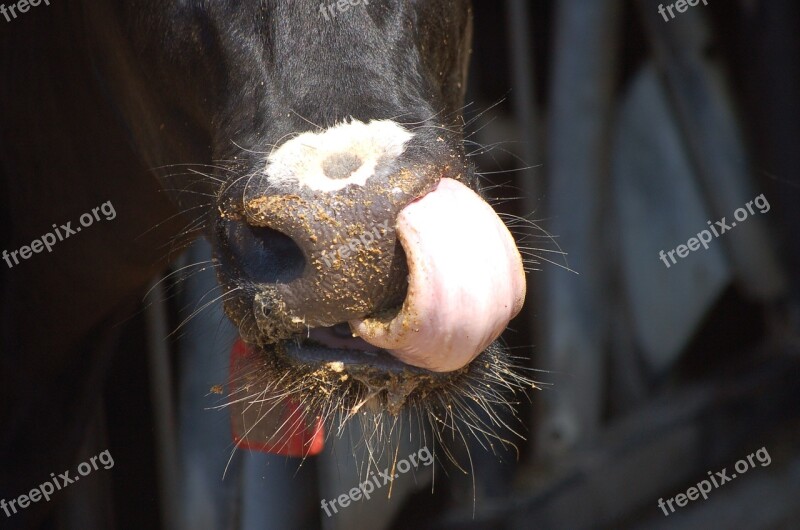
[232,121,450,339]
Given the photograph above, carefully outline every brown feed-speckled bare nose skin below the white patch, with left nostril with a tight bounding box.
[241,188,408,338]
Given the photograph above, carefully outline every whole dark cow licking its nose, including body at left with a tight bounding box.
[0,0,527,524]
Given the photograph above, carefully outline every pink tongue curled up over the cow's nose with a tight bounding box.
[350,179,525,372]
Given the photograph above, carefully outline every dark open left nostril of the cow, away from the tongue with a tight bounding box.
[227,221,306,283]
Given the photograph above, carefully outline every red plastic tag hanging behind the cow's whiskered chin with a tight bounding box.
[228,339,325,457]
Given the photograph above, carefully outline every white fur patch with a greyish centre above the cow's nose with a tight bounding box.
[265,120,414,192]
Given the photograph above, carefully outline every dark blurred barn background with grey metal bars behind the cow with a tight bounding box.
[31,0,800,530]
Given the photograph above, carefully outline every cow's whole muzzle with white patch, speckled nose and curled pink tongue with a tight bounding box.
[220,117,525,387]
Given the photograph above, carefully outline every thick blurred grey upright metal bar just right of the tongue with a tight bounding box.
[538,0,622,459]
